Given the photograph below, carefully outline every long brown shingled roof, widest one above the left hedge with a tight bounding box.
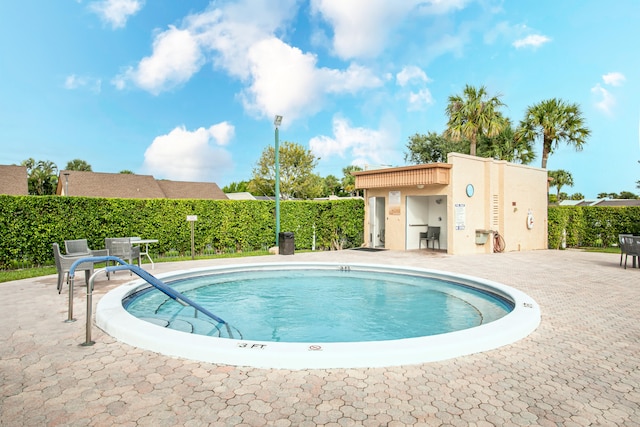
[56,170,227,199]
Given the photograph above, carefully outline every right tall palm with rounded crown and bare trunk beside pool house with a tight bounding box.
[516,98,591,169]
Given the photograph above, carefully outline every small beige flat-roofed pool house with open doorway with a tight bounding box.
[354,153,548,254]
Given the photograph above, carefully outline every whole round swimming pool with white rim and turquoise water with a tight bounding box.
[96,263,540,369]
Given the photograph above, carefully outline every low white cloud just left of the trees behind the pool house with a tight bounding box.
[309,117,397,171]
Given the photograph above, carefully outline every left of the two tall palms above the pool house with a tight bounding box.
[445,85,504,156]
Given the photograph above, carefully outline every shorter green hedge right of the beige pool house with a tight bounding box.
[549,206,640,249]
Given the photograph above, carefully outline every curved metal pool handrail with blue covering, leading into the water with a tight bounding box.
[67,256,242,346]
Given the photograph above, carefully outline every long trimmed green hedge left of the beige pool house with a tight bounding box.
[0,195,364,268]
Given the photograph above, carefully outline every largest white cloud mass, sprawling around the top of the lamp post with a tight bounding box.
[112,0,383,124]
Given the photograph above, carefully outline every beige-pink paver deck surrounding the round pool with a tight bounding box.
[0,250,640,426]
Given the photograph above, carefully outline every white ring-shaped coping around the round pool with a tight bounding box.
[96,263,541,369]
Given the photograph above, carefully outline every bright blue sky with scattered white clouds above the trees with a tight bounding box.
[0,0,640,198]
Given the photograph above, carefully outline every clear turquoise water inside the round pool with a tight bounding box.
[123,268,513,343]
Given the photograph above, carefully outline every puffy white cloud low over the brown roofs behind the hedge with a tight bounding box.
[142,122,235,182]
